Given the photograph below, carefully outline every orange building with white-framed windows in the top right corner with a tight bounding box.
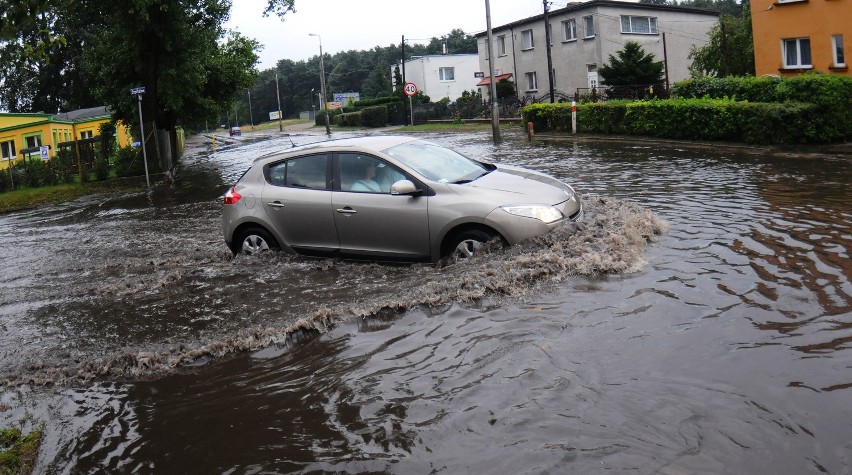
[751,0,852,76]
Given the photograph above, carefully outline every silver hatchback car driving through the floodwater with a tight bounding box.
[222,136,583,262]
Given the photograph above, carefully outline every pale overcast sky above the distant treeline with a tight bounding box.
[225,0,548,70]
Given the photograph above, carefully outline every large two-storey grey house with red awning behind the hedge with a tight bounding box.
[476,0,719,100]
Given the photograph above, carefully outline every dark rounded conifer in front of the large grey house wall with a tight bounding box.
[598,41,663,86]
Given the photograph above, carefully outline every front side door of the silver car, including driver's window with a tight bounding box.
[332,153,430,259]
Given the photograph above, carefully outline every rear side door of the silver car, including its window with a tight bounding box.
[262,154,339,253]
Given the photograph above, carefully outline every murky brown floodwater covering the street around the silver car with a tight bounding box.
[0,134,852,474]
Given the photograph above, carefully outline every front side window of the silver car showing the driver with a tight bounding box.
[338,153,406,194]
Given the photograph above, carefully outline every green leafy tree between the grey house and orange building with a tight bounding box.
[689,9,754,77]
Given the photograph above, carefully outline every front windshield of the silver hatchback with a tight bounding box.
[384,140,489,183]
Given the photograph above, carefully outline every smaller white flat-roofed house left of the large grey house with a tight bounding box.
[391,54,481,102]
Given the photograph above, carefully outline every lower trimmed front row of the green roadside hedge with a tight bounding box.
[523,99,824,144]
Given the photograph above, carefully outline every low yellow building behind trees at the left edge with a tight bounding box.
[0,107,132,169]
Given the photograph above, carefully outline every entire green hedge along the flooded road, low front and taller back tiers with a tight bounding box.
[522,74,852,144]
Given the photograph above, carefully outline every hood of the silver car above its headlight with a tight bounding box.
[451,165,574,205]
